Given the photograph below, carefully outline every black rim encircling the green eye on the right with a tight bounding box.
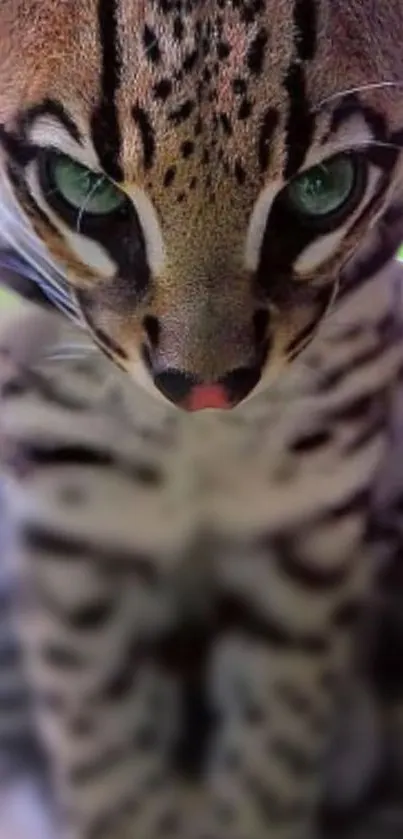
[277,152,367,233]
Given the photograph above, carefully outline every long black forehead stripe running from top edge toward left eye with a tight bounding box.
[91,0,123,182]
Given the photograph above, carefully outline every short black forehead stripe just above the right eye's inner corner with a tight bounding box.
[284,63,315,180]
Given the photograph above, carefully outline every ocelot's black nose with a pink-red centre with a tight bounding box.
[154,365,261,411]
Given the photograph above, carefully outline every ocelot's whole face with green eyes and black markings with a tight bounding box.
[0,0,403,410]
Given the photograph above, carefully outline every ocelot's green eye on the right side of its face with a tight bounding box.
[286,155,357,221]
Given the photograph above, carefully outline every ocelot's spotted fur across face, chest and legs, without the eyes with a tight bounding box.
[0,0,403,839]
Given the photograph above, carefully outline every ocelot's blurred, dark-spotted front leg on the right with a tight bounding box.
[207,506,378,839]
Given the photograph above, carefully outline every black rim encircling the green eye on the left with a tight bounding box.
[38,151,132,234]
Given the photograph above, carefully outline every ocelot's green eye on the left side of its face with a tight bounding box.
[44,154,127,216]
